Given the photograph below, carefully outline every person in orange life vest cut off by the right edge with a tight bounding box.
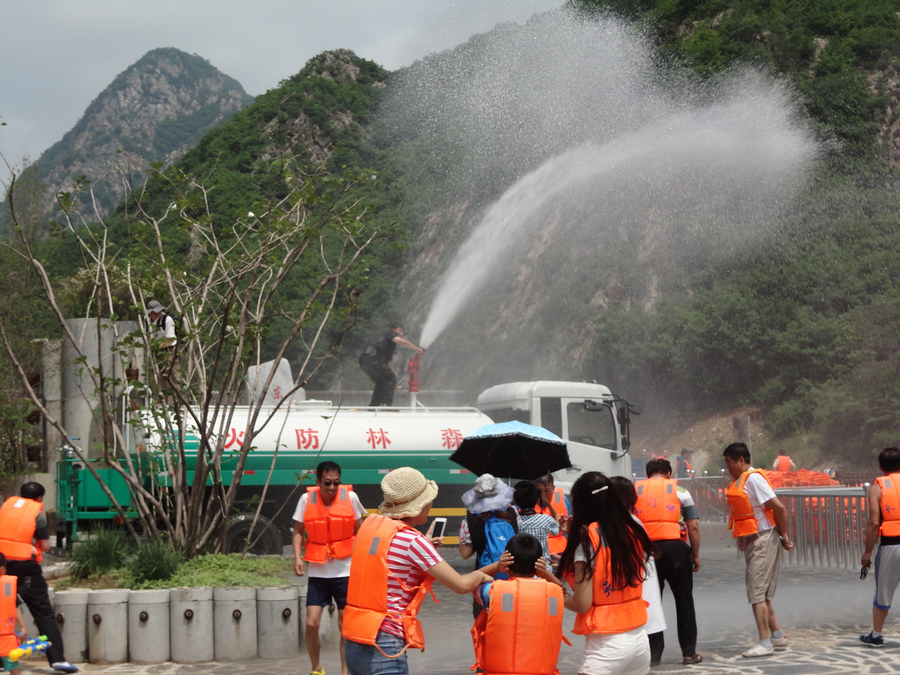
[859,447,900,647]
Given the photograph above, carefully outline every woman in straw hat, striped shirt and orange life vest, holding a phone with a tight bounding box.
[341,466,491,675]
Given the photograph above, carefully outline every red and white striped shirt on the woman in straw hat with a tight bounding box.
[381,528,443,638]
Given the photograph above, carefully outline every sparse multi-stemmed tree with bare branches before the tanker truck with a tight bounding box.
[0,160,379,554]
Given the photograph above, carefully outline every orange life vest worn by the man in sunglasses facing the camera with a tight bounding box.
[303,485,356,563]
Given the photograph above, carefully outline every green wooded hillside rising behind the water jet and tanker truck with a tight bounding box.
[4,0,900,476]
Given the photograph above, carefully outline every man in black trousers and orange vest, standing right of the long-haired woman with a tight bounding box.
[635,459,703,666]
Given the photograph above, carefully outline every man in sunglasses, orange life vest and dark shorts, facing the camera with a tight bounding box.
[292,462,368,675]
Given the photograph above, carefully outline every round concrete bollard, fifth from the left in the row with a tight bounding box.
[213,586,259,661]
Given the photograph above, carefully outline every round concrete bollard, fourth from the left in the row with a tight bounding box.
[169,586,215,663]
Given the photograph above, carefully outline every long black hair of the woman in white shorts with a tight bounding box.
[559,471,653,588]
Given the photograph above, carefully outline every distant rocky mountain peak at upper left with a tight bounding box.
[35,48,253,220]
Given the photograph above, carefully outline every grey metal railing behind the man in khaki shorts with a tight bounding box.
[678,476,869,569]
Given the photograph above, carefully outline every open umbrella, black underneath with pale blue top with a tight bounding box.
[450,421,572,480]
